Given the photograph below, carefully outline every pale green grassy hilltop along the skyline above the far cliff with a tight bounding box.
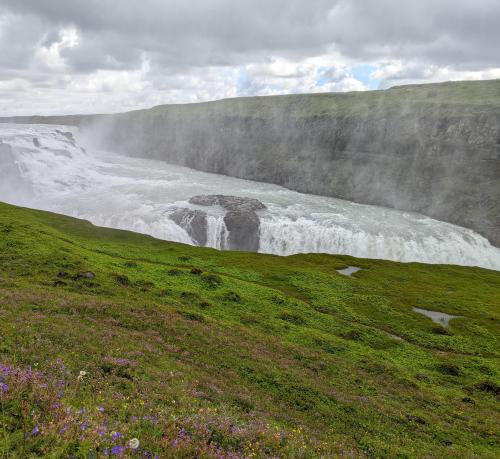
[0,80,500,125]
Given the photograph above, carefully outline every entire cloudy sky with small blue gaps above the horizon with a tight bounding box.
[0,0,500,116]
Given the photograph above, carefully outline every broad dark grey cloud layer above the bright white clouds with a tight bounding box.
[0,0,500,72]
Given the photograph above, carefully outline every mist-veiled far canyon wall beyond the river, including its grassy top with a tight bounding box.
[3,80,500,250]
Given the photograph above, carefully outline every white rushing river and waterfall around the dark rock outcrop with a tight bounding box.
[0,124,500,270]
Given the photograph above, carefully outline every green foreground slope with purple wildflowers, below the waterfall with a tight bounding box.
[0,203,500,458]
